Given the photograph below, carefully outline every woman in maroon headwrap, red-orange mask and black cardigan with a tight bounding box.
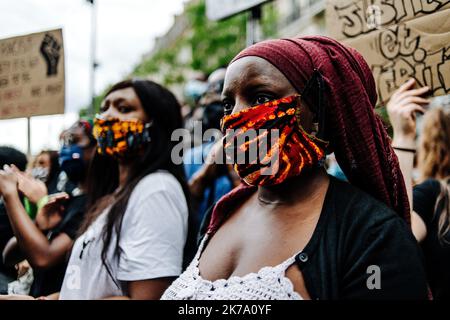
[163,37,427,299]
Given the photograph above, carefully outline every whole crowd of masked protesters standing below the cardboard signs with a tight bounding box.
[0,36,450,300]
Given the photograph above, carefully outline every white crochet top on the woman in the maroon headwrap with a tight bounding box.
[161,235,303,300]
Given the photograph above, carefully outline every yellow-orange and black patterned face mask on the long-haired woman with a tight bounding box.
[94,117,151,159]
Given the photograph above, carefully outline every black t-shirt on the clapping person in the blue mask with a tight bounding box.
[30,195,86,297]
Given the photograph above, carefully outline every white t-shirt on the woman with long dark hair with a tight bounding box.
[60,171,188,300]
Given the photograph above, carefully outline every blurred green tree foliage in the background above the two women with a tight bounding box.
[80,0,277,117]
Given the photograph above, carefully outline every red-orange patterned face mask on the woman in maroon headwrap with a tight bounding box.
[221,95,328,186]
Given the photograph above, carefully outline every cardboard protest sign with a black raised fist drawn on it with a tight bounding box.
[0,29,65,119]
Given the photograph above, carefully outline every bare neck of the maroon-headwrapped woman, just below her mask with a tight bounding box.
[258,168,329,205]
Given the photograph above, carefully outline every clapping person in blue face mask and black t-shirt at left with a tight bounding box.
[0,121,96,297]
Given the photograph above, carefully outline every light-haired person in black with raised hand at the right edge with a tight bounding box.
[388,80,450,300]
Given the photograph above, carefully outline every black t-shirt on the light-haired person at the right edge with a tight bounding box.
[413,179,450,300]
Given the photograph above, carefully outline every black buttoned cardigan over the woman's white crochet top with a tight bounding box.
[202,177,428,300]
